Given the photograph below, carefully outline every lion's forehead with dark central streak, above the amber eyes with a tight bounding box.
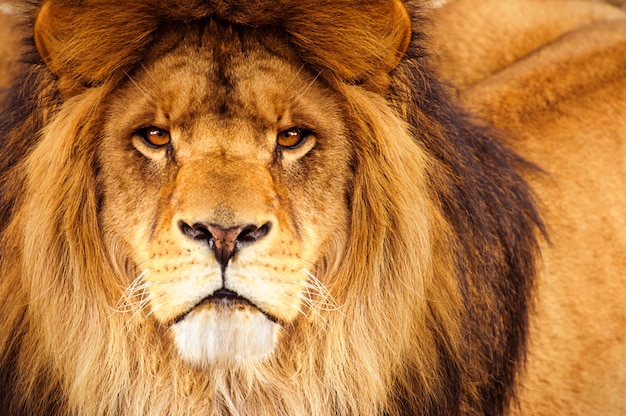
[127,28,326,139]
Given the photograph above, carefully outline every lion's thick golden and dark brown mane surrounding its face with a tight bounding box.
[0,0,588,415]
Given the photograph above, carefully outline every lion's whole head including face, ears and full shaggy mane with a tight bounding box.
[0,0,538,415]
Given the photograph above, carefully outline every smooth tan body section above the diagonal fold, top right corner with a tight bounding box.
[432,0,624,89]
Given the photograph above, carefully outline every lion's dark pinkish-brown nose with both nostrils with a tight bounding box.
[179,221,271,268]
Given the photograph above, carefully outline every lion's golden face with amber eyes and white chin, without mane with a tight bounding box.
[98,25,351,366]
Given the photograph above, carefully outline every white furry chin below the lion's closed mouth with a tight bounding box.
[172,305,279,367]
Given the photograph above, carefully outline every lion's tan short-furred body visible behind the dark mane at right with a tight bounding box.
[432,0,626,415]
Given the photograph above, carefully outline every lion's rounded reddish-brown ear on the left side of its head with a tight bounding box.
[33,0,159,95]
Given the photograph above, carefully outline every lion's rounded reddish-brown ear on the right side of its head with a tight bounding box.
[286,0,412,90]
